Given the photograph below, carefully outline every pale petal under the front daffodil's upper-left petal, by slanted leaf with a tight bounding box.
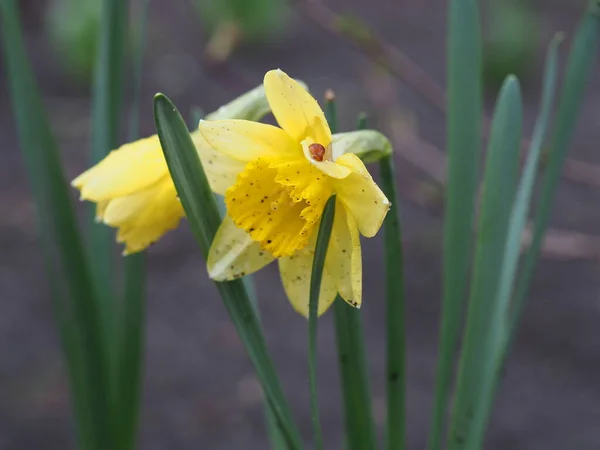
[190,130,246,195]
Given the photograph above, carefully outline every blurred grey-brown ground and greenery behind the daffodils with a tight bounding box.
[0,0,600,450]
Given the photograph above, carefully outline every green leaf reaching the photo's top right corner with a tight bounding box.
[503,1,600,359]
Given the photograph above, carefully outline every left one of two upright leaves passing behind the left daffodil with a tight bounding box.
[88,0,129,338]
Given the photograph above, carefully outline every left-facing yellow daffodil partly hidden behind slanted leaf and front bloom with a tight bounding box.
[72,86,269,254]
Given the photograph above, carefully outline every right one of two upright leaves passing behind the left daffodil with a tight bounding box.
[115,0,150,450]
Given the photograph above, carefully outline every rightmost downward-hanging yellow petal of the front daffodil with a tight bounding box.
[325,200,362,308]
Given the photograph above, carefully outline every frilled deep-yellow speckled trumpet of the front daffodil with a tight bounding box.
[225,158,332,258]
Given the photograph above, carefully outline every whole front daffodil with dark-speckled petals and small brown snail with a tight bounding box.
[199,70,390,316]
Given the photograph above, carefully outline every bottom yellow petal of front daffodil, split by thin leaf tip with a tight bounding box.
[279,244,337,317]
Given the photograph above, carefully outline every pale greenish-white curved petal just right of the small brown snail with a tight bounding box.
[331,130,392,163]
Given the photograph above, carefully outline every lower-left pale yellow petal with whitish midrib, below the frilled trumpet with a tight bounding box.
[207,216,275,281]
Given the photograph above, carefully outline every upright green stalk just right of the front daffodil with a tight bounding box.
[379,156,406,450]
